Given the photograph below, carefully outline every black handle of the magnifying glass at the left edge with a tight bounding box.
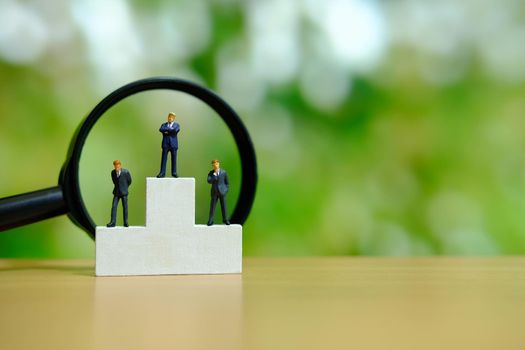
[0,186,69,232]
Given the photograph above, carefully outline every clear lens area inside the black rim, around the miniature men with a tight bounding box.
[79,90,241,226]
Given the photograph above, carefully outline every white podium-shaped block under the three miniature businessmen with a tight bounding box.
[96,177,242,276]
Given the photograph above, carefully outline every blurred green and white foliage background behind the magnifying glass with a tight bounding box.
[0,0,525,258]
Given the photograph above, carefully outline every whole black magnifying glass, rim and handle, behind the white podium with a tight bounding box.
[0,77,257,239]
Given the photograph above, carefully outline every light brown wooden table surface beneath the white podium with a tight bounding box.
[0,257,525,350]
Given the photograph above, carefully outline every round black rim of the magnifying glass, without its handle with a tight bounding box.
[59,77,257,239]
